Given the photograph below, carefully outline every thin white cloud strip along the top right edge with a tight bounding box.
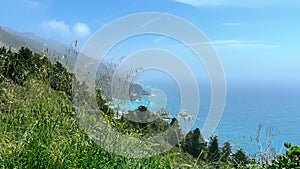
[174,0,300,7]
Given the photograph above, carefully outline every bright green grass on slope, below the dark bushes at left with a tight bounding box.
[0,80,175,168]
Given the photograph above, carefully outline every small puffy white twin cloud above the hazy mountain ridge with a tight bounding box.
[40,20,90,38]
